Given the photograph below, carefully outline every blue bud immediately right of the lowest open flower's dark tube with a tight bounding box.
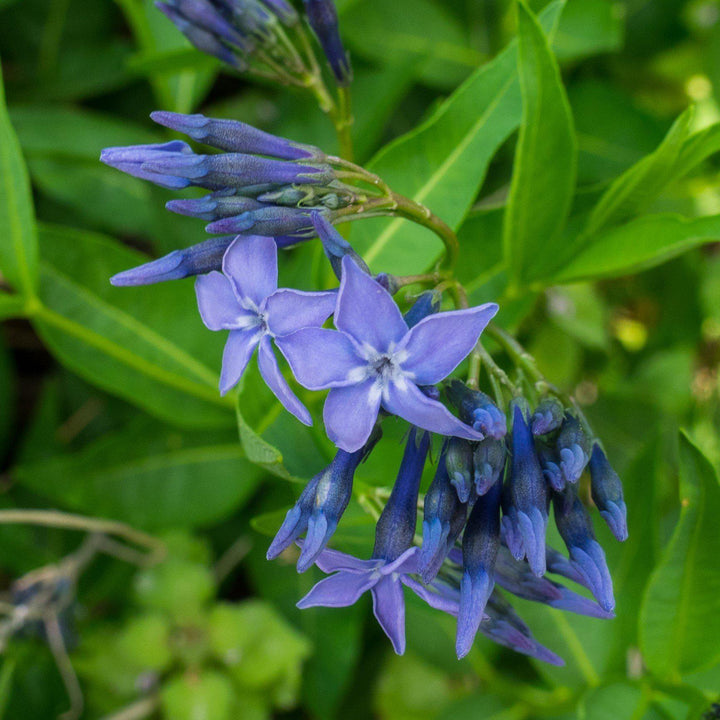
[418,442,467,583]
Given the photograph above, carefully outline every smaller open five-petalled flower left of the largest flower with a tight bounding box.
[195,236,337,425]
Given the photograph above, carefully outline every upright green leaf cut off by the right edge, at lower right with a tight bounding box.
[640,434,720,680]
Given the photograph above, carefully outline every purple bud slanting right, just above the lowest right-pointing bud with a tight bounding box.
[495,547,613,618]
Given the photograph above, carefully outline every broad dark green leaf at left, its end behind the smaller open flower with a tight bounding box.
[33,226,232,427]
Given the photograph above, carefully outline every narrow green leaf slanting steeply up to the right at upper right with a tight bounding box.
[581,107,693,236]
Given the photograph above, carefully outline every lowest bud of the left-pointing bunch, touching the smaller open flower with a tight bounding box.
[110,235,235,287]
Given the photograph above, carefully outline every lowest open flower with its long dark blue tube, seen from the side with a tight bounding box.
[297,428,430,655]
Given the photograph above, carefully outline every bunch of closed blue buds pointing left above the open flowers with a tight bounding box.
[100,112,410,285]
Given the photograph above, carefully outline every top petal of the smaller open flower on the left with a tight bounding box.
[223,235,277,306]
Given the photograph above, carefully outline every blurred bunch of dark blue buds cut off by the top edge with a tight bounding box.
[156,0,352,86]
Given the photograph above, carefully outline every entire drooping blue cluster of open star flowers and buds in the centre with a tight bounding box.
[102,42,627,664]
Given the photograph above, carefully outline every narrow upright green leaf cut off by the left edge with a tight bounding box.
[0,58,38,297]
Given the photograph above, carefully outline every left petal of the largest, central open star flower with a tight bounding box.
[275,328,365,390]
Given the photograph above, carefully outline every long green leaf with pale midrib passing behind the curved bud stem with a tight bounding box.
[352,1,563,275]
